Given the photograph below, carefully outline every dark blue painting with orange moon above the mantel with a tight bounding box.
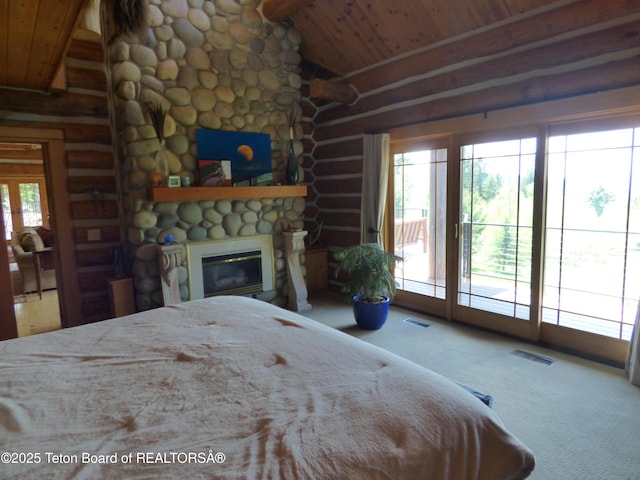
[196,129,272,183]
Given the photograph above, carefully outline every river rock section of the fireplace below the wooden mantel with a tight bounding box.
[128,194,306,310]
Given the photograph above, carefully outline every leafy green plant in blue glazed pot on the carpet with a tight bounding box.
[335,243,402,330]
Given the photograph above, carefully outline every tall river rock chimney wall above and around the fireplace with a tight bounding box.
[109,0,304,310]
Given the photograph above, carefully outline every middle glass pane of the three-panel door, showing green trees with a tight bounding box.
[456,138,537,320]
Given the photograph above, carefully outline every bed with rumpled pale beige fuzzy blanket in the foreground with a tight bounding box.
[0,296,535,480]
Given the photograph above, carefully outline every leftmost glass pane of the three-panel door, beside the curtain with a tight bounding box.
[393,148,447,299]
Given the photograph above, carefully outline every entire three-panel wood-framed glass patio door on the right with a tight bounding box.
[392,117,640,361]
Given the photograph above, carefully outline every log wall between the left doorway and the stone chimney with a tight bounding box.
[0,40,121,326]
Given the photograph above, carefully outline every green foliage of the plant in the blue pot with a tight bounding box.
[335,243,402,299]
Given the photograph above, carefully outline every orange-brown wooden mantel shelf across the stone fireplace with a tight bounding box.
[149,185,307,202]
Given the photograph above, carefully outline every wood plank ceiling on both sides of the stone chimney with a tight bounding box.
[0,0,580,90]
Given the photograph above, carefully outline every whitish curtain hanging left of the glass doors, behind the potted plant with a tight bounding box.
[360,133,390,248]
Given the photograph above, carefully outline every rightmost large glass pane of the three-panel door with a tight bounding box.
[542,128,640,340]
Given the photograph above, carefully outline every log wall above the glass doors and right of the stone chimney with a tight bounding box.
[312,0,640,284]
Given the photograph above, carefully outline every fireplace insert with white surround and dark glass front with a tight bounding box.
[187,235,275,300]
